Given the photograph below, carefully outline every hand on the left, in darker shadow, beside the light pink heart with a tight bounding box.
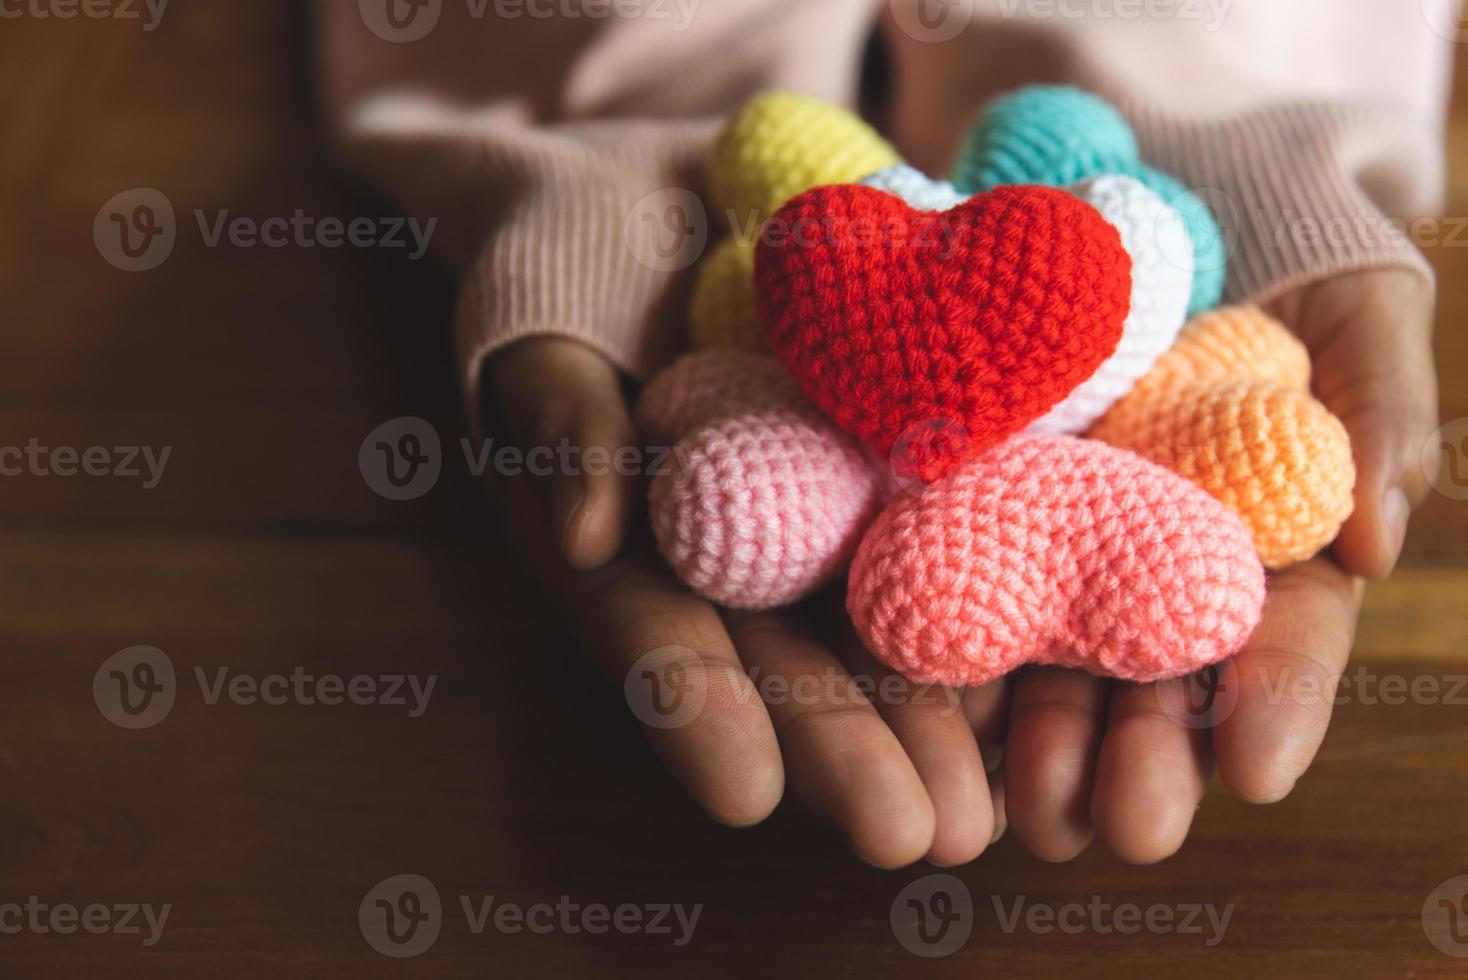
[484,337,1004,867]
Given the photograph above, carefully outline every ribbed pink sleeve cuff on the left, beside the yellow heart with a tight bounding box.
[455,122,716,398]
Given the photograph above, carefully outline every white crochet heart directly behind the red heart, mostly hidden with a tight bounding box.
[862,164,1193,436]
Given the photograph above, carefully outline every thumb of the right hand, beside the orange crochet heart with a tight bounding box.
[1285,270,1437,578]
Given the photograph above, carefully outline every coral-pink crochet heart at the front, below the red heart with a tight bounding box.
[847,436,1264,685]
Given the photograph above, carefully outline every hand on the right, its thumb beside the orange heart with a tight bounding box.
[1004,270,1437,863]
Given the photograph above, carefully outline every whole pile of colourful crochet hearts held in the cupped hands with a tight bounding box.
[639,88,1355,685]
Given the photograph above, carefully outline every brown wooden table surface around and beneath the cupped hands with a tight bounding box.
[0,0,1468,977]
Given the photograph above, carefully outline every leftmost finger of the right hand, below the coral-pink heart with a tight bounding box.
[1004,668,1105,861]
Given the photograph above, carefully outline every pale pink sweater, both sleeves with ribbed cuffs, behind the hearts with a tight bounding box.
[319,0,1455,387]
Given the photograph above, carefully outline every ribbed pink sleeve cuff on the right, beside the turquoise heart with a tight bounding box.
[1129,104,1442,302]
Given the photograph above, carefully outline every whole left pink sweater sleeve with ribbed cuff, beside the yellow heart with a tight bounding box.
[319,0,876,390]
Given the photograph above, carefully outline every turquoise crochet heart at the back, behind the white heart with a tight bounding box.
[953,85,1229,315]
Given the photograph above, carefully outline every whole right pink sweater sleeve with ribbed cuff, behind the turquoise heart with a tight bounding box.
[884,0,1450,309]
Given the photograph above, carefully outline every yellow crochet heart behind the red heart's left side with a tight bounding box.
[688,92,901,351]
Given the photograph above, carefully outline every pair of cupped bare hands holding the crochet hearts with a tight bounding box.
[490,270,1437,867]
